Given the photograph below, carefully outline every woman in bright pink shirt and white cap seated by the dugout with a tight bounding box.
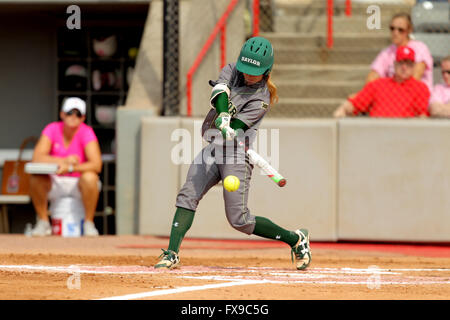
[30,98,102,236]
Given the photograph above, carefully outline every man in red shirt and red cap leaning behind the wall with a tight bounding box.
[334,46,430,118]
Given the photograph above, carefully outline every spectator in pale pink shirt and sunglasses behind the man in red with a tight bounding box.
[366,13,433,92]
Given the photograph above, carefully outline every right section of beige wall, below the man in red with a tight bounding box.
[338,119,450,241]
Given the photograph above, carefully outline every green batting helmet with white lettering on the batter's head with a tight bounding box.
[236,37,273,76]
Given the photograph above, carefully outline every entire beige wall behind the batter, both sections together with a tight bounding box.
[139,118,450,242]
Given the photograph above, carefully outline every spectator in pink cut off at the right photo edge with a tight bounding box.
[430,56,450,118]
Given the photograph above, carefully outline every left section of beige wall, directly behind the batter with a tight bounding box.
[140,118,337,240]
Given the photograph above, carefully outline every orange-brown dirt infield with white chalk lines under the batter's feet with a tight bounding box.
[0,235,450,300]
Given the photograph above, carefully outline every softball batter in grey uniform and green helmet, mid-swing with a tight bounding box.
[155,37,311,270]
